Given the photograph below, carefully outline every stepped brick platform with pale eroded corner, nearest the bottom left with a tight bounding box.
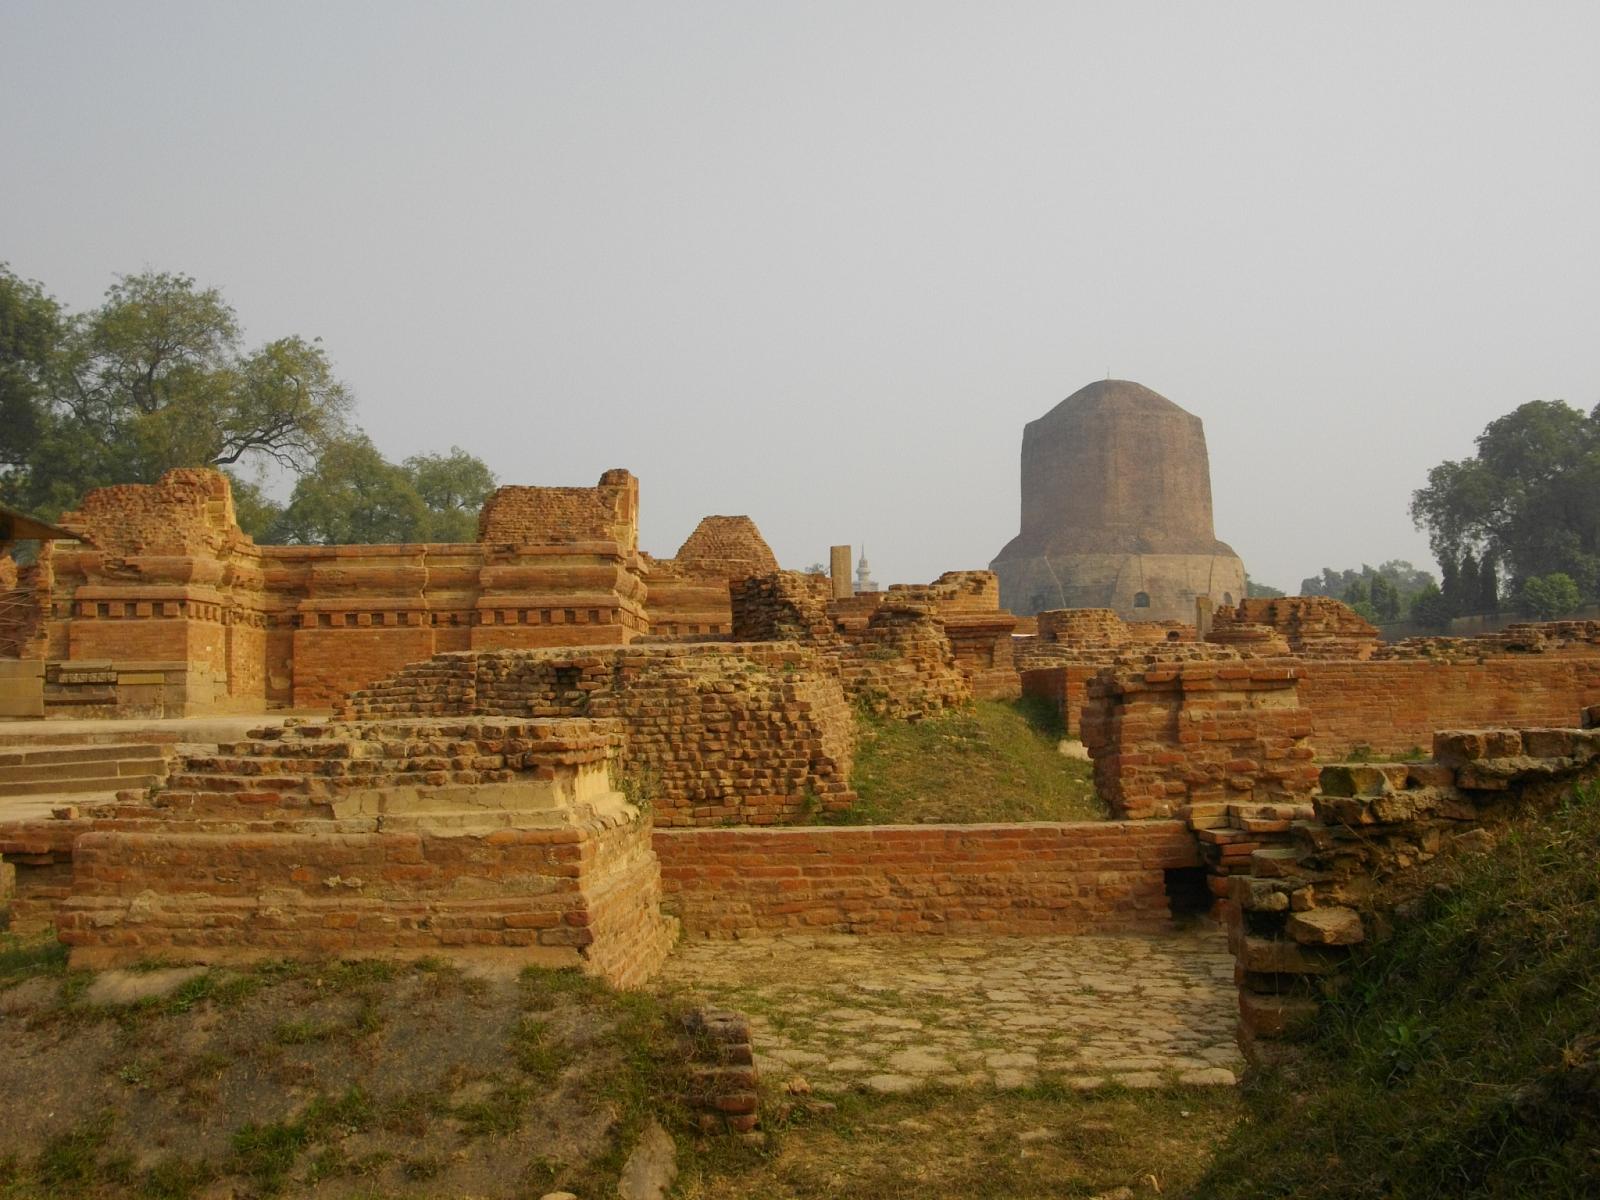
[56,718,674,986]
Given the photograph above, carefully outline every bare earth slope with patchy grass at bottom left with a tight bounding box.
[0,939,682,1200]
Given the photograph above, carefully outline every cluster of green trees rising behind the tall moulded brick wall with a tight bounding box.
[0,264,494,544]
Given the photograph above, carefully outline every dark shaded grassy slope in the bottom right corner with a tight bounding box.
[1198,786,1600,1200]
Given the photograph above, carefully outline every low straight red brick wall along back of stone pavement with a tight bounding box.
[654,821,1200,938]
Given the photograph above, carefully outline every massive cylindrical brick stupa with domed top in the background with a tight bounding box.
[989,379,1245,621]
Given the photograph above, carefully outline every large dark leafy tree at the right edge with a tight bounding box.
[1411,400,1600,598]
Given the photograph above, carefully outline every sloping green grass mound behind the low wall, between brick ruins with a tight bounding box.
[821,698,1107,826]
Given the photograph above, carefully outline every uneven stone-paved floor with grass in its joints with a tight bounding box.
[661,930,1242,1091]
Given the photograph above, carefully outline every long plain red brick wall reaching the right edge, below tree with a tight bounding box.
[1301,654,1600,758]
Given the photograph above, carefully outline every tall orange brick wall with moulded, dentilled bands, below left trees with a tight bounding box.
[28,470,648,715]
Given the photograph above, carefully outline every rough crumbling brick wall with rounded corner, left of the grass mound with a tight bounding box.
[339,643,854,826]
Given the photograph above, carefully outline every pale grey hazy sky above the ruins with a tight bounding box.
[0,0,1600,589]
